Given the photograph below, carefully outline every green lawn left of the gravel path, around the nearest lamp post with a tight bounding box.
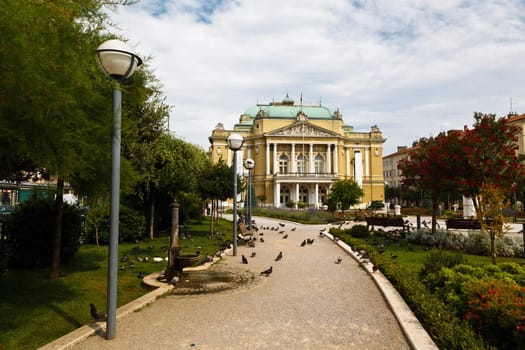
[0,220,231,350]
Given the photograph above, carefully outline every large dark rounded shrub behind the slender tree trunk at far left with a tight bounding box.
[3,197,81,268]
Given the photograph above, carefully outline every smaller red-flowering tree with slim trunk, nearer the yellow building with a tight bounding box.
[398,131,463,233]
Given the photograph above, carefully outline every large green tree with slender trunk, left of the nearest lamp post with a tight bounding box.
[0,0,145,278]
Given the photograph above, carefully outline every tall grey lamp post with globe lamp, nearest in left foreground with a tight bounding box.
[97,39,142,340]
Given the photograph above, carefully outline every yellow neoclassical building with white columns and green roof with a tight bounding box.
[209,95,385,208]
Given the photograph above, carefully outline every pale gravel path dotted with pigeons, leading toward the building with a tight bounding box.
[73,218,410,350]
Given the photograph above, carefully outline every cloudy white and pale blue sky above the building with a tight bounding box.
[105,0,525,155]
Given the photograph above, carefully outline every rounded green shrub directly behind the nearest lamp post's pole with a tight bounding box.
[85,206,146,244]
